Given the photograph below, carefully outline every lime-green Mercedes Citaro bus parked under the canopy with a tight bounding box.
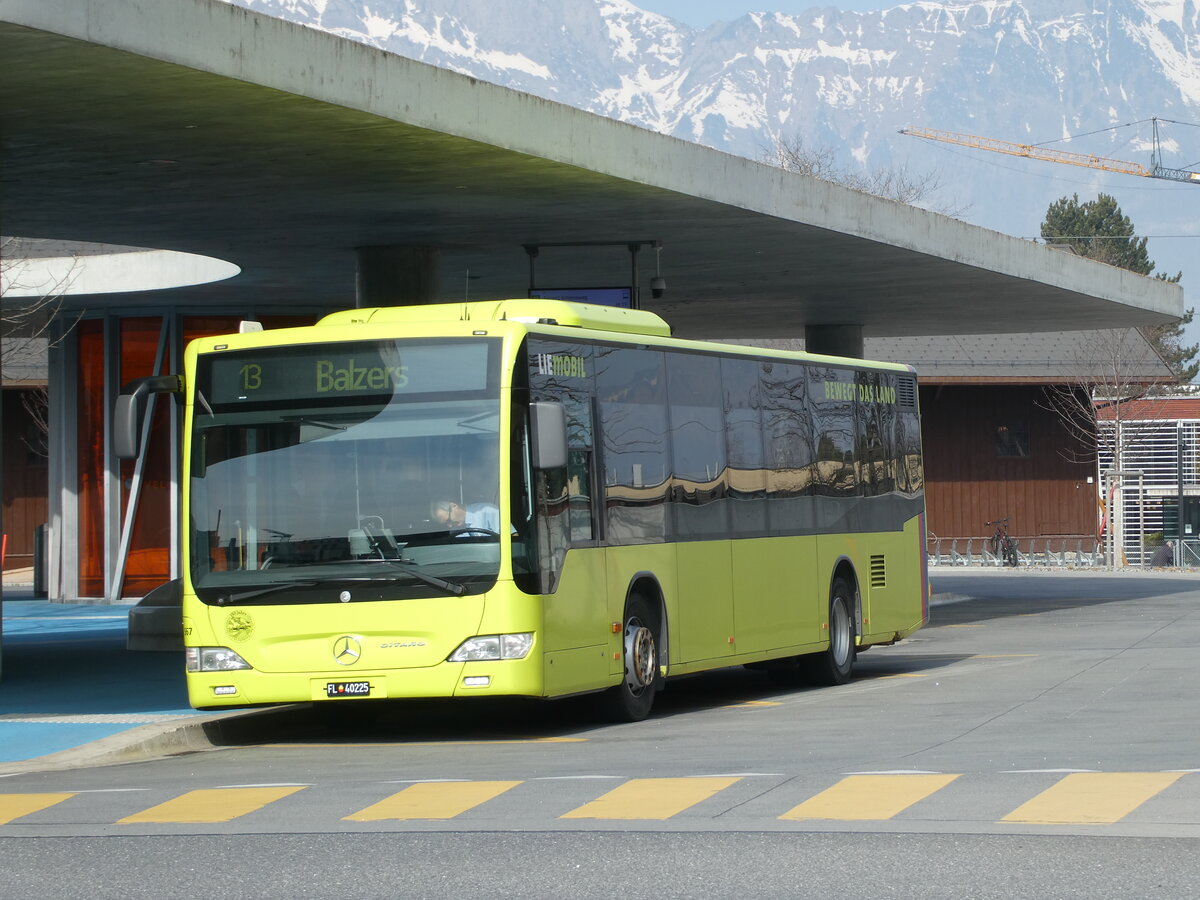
[114,299,929,720]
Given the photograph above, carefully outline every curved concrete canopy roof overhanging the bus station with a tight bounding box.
[0,0,1183,337]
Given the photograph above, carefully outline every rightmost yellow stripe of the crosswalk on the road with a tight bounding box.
[1000,772,1183,824]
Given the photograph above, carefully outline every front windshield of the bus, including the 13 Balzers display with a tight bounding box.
[187,338,508,604]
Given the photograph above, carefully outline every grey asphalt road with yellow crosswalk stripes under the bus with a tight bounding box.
[0,571,1200,898]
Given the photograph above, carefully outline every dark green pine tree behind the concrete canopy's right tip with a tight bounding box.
[1042,193,1200,384]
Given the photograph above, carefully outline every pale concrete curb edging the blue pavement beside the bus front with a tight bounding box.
[0,703,308,775]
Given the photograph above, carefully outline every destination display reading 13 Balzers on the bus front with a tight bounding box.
[200,340,496,407]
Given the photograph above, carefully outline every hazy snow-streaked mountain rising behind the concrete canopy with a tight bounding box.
[229,0,1200,285]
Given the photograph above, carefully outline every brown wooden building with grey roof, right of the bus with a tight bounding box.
[883,330,1170,548]
